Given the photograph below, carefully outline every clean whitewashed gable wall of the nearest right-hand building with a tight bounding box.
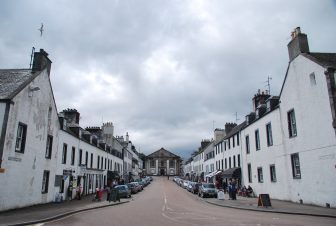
[280,55,336,207]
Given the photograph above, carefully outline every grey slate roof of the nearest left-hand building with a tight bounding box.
[0,69,36,99]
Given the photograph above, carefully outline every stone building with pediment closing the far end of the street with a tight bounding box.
[145,148,182,176]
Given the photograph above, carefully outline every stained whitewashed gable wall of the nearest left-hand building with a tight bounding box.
[0,70,59,210]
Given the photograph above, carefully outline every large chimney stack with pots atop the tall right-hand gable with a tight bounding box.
[287,27,309,61]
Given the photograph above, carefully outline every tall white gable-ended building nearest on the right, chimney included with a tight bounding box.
[280,28,336,207]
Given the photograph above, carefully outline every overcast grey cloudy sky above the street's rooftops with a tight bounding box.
[0,0,336,158]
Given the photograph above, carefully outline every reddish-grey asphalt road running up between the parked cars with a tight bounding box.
[44,177,335,226]
